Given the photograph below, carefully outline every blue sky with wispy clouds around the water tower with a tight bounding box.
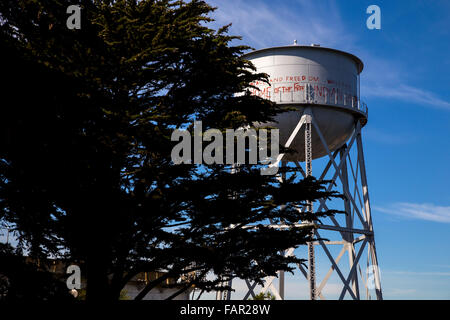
[209,0,450,299]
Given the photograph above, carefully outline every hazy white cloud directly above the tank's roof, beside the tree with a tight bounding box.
[209,0,354,48]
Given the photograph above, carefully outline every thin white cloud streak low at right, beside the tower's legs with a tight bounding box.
[374,202,450,223]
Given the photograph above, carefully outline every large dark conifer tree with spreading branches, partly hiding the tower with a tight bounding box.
[0,0,336,300]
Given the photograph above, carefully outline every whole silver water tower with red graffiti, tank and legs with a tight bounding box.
[217,42,382,299]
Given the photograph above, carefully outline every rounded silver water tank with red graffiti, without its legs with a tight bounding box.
[244,44,367,161]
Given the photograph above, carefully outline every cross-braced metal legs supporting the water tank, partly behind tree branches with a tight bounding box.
[217,107,383,300]
